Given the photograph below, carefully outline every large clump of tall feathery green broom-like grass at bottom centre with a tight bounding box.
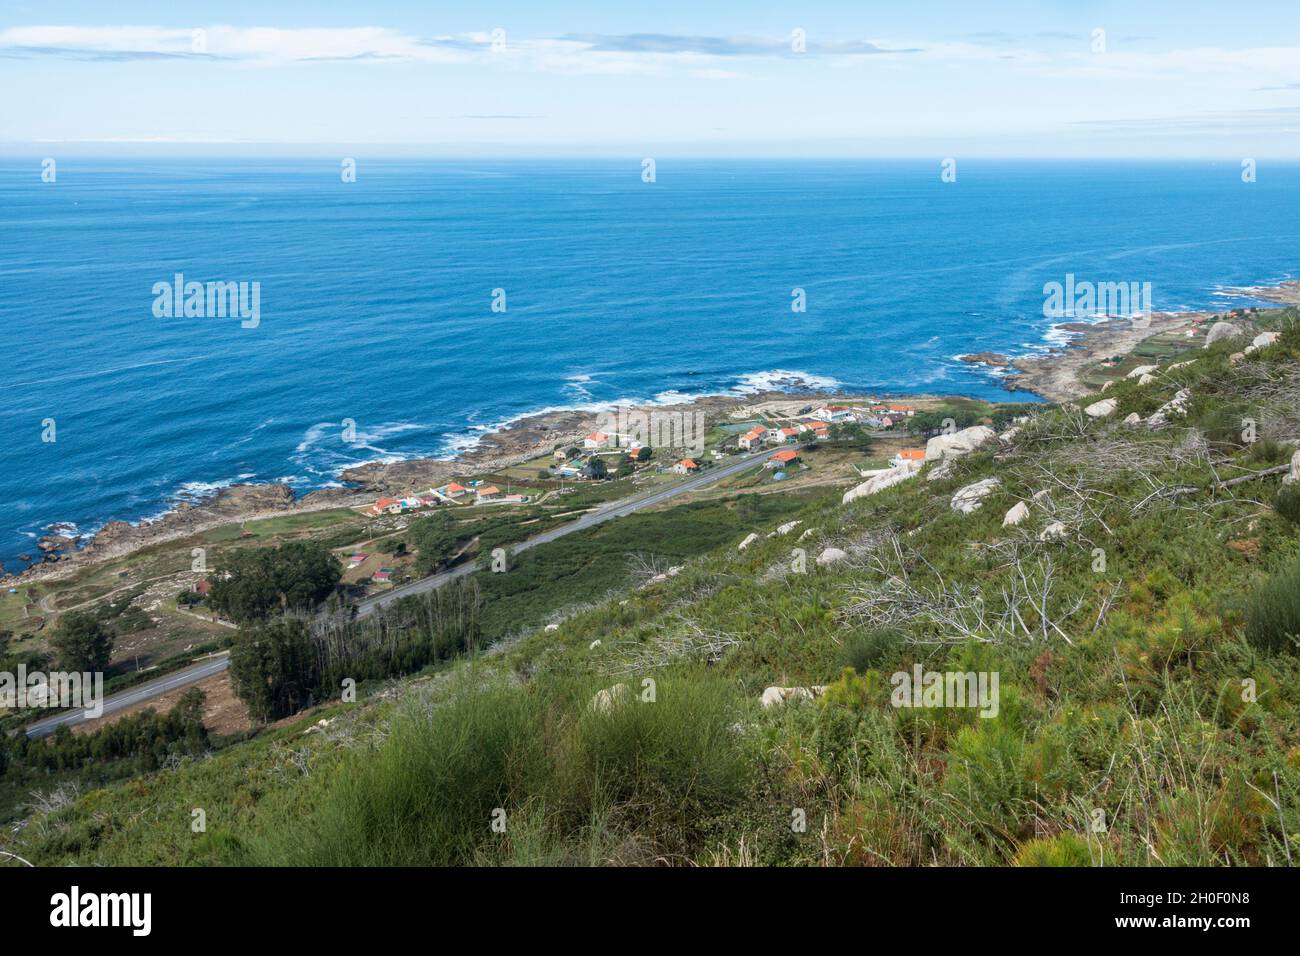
[260,674,749,866]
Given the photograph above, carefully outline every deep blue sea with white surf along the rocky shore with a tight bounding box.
[0,157,1300,570]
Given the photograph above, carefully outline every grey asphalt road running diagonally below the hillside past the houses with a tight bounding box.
[26,446,785,737]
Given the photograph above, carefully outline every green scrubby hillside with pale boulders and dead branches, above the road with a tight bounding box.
[0,311,1300,865]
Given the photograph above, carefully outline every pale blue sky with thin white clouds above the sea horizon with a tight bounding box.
[0,0,1300,159]
